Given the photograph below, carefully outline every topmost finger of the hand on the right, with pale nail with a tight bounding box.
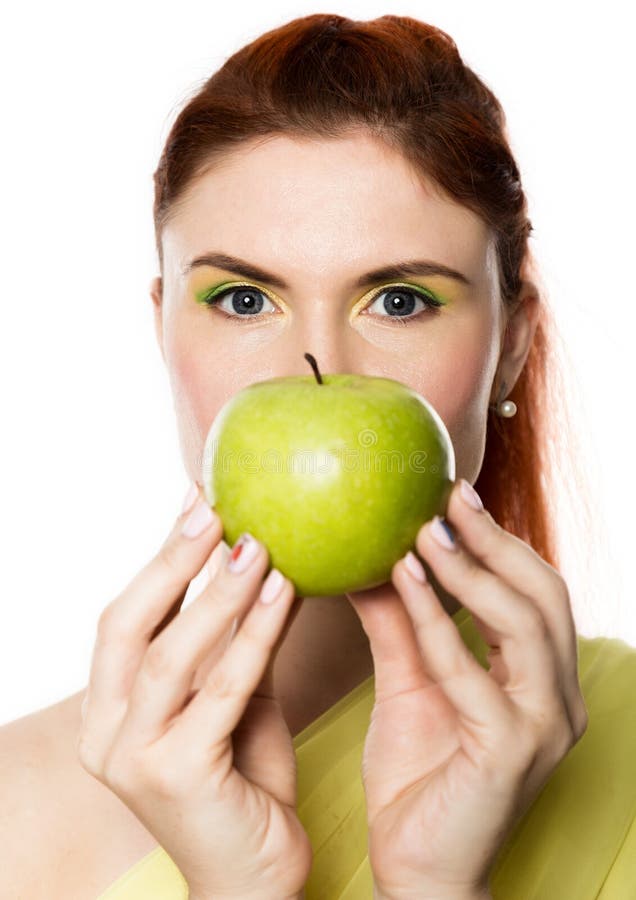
[447,481,585,723]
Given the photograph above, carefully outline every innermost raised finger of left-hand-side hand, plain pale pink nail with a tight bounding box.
[171,569,294,763]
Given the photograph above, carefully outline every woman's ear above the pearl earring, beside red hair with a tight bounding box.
[490,270,540,403]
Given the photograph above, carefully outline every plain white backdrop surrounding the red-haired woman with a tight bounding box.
[0,0,636,722]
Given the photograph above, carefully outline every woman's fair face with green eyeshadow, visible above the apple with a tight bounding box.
[151,134,506,483]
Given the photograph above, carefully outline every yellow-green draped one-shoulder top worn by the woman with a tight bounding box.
[98,607,636,900]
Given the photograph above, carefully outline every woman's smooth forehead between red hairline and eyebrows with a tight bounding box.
[163,133,494,284]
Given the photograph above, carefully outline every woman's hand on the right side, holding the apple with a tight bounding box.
[347,482,587,900]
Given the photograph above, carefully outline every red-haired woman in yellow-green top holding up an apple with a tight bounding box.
[3,15,636,900]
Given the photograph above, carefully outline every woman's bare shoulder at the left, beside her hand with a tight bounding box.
[0,691,156,900]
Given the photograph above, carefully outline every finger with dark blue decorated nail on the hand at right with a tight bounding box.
[416,516,561,712]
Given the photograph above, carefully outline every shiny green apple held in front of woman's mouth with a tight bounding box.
[202,374,455,597]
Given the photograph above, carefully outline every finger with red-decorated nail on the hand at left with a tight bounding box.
[121,536,269,746]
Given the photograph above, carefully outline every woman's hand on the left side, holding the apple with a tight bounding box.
[77,488,312,900]
